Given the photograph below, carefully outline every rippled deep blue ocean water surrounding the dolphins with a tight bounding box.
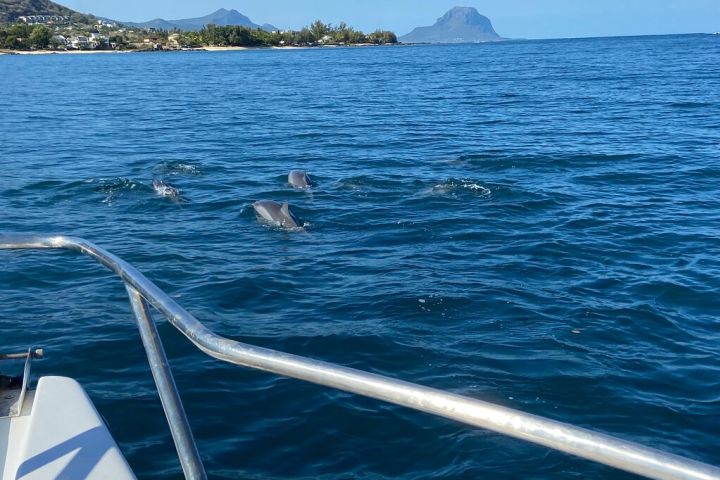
[0,35,720,479]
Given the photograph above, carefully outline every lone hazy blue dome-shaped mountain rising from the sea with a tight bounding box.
[398,7,505,43]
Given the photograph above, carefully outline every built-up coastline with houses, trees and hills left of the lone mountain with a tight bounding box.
[0,0,397,53]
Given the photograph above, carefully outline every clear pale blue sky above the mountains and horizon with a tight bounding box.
[60,0,720,38]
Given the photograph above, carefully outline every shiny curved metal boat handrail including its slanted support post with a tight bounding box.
[0,236,720,480]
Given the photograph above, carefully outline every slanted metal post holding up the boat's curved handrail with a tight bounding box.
[125,285,207,480]
